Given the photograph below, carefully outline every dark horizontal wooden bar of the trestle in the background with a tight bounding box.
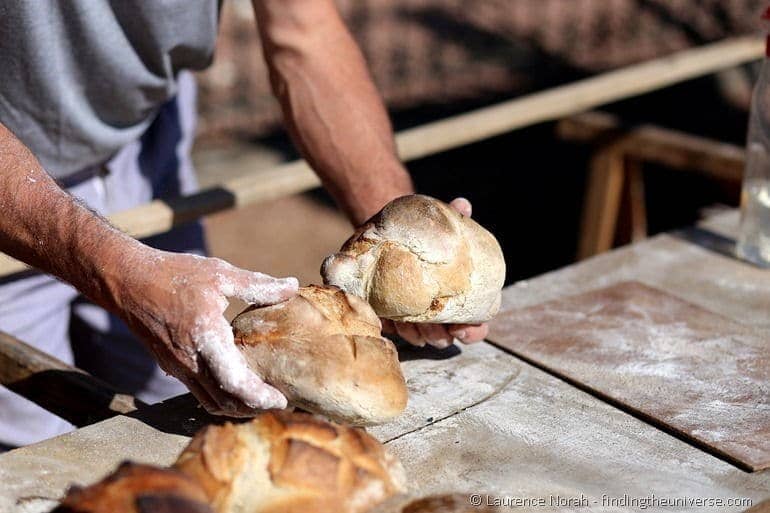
[556,112,746,182]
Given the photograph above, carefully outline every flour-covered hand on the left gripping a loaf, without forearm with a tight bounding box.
[116,248,298,416]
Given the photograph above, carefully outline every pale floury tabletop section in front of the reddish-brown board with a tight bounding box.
[388,352,770,513]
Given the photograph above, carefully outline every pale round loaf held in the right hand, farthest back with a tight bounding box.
[321,195,505,323]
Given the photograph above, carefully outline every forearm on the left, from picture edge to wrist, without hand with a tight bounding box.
[0,124,138,308]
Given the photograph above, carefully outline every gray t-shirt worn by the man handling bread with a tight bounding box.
[0,0,219,178]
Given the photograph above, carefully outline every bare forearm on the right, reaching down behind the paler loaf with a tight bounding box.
[254,0,413,224]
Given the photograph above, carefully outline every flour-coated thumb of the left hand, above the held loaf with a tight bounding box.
[217,261,299,306]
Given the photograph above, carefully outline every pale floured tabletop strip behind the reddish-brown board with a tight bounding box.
[501,230,770,335]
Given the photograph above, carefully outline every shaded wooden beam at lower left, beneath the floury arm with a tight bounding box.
[0,332,146,427]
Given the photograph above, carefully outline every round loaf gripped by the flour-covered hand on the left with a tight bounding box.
[232,285,407,425]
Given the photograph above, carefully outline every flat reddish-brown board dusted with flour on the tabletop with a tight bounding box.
[489,282,770,471]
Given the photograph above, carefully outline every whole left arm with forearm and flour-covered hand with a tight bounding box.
[0,124,297,415]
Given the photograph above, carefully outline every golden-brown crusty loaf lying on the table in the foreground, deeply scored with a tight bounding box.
[174,411,405,513]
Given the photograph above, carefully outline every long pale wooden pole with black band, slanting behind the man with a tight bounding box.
[0,36,765,276]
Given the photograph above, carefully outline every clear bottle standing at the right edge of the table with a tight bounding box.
[736,16,770,267]
